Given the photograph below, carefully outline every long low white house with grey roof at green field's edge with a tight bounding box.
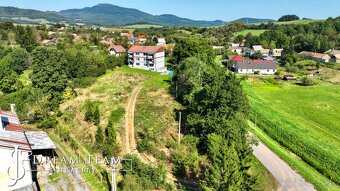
[233,60,277,75]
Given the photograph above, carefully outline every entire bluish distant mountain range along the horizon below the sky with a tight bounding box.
[0,4,274,27]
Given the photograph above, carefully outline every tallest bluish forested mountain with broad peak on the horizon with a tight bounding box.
[59,4,224,26]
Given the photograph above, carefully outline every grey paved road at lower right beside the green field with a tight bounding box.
[253,142,315,191]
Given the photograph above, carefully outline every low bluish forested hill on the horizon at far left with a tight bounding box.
[0,7,66,22]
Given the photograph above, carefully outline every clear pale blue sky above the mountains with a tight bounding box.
[0,0,340,21]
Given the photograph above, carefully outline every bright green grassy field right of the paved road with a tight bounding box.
[243,78,340,188]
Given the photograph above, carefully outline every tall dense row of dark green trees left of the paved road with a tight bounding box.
[173,39,254,190]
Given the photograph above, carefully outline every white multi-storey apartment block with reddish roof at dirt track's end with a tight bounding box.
[128,46,166,72]
